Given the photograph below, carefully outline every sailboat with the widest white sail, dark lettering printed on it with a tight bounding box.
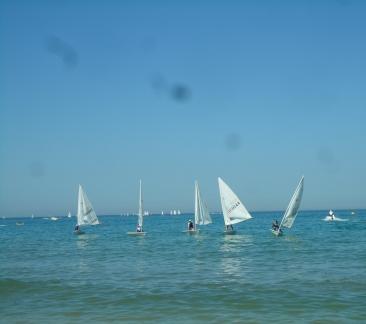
[218,178,252,234]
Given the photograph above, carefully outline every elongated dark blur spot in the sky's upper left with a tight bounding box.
[46,36,79,68]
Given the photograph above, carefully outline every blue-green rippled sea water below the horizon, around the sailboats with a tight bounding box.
[0,210,366,323]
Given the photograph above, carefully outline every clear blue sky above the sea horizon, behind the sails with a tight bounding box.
[0,0,366,216]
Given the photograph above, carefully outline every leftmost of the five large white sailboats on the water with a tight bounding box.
[74,185,99,234]
